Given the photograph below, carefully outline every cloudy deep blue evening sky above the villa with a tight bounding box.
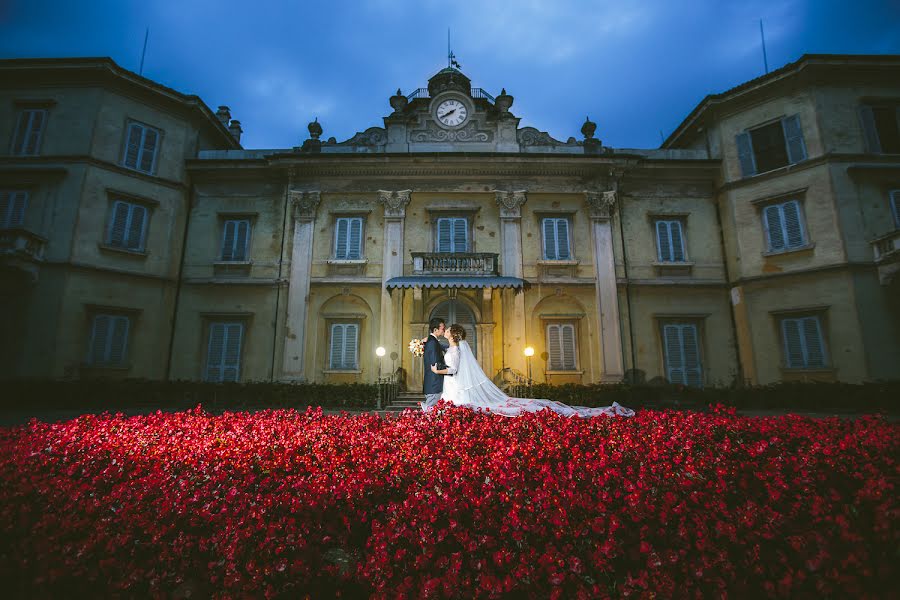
[0,0,900,148]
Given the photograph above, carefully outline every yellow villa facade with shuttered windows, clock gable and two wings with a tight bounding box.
[0,55,900,389]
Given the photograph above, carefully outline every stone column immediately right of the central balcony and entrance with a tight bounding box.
[496,190,532,373]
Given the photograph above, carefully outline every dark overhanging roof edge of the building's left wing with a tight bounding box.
[0,56,241,149]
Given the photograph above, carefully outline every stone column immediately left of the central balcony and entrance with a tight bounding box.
[374,190,411,382]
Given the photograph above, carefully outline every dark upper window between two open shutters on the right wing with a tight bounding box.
[737,115,806,177]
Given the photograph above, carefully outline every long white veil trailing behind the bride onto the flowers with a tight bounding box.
[454,340,634,417]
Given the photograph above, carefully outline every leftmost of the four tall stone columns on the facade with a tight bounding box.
[282,190,319,381]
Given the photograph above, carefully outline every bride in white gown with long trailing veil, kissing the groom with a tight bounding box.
[431,324,634,417]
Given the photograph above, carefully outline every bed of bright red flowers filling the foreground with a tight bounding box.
[0,406,900,598]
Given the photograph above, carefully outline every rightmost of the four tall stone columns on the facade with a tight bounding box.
[585,190,625,383]
